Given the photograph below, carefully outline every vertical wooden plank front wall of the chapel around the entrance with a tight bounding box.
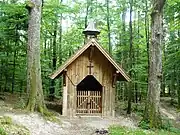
[67,48,115,116]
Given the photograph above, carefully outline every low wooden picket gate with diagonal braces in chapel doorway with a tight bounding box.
[76,91,102,115]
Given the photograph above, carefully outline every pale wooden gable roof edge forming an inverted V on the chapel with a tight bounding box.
[50,38,131,81]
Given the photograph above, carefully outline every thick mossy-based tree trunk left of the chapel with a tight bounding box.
[27,0,46,113]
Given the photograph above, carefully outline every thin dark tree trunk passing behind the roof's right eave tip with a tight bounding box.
[127,0,133,114]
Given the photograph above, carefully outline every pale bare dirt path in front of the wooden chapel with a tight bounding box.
[4,112,136,135]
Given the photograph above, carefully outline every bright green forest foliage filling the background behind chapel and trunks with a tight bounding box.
[0,0,180,120]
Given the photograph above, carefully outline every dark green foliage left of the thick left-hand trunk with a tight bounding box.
[0,3,28,92]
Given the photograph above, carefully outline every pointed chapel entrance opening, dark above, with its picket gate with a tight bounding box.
[76,75,102,115]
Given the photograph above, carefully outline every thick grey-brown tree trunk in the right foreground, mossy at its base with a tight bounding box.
[144,0,165,128]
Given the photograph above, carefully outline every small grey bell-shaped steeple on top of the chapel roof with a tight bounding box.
[83,21,100,39]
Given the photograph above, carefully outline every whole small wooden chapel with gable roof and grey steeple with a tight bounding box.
[50,22,130,117]
